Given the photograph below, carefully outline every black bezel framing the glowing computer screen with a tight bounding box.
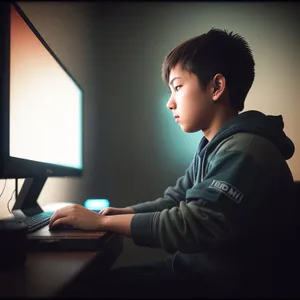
[0,2,84,178]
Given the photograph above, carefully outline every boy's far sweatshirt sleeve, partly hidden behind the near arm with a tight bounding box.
[129,156,195,213]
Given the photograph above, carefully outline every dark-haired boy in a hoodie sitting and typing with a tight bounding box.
[49,29,294,295]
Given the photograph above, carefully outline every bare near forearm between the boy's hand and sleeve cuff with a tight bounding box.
[99,214,134,237]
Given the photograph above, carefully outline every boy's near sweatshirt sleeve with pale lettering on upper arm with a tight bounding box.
[131,151,266,253]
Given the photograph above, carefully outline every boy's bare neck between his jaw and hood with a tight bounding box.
[202,109,238,142]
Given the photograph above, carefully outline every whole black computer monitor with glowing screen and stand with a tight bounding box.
[0,2,83,215]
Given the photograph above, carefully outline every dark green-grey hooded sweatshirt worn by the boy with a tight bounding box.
[131,111,294,285]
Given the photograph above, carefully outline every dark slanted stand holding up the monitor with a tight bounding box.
[12,177,47,219]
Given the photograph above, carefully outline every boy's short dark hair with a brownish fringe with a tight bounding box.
[162,28,255,111]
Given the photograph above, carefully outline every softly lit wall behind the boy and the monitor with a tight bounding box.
[0,2,300,265]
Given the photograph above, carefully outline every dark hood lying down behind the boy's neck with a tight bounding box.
[208,110,295,160]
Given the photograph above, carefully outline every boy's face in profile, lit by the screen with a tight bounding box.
[167,64,215,132]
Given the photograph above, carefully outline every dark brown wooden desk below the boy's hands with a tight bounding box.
[0,234,123,298]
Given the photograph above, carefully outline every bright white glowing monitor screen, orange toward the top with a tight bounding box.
[9,5,83,170]
